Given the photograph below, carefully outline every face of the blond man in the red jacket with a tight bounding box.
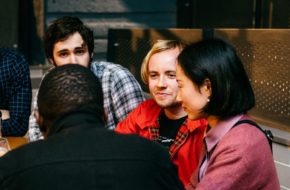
[148,48,180,108]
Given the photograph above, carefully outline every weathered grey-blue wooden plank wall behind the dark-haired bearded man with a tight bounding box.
[45,0,176,60]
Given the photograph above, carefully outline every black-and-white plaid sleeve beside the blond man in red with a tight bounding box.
[111,68,145,122]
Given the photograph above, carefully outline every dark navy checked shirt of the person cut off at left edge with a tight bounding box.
[0,48,32,136]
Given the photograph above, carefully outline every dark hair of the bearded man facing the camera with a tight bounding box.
[44,16,94,59]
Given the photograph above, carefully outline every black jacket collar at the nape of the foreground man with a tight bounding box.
[48,109,104,136]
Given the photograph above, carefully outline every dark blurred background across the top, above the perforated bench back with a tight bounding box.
[0,0,290,65]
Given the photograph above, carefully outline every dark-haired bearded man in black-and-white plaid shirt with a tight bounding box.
[28,16,145,141]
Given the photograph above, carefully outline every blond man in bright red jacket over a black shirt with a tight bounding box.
[115,40,206,185]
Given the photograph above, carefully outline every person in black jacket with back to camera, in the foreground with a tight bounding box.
[0,64,183,190]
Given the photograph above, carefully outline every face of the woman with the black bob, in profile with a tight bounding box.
[176,65,211,120]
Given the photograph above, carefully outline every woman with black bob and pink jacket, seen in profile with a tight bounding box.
[176,39,280,190]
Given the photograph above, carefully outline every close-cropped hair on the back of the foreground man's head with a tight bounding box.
[37,64,104,127]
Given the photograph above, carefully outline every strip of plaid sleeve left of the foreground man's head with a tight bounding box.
[28,91,43,142]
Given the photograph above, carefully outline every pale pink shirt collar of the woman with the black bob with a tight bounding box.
[204,114,244,152]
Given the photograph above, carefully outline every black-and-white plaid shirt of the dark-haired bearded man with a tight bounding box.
[29,61,145,141]
